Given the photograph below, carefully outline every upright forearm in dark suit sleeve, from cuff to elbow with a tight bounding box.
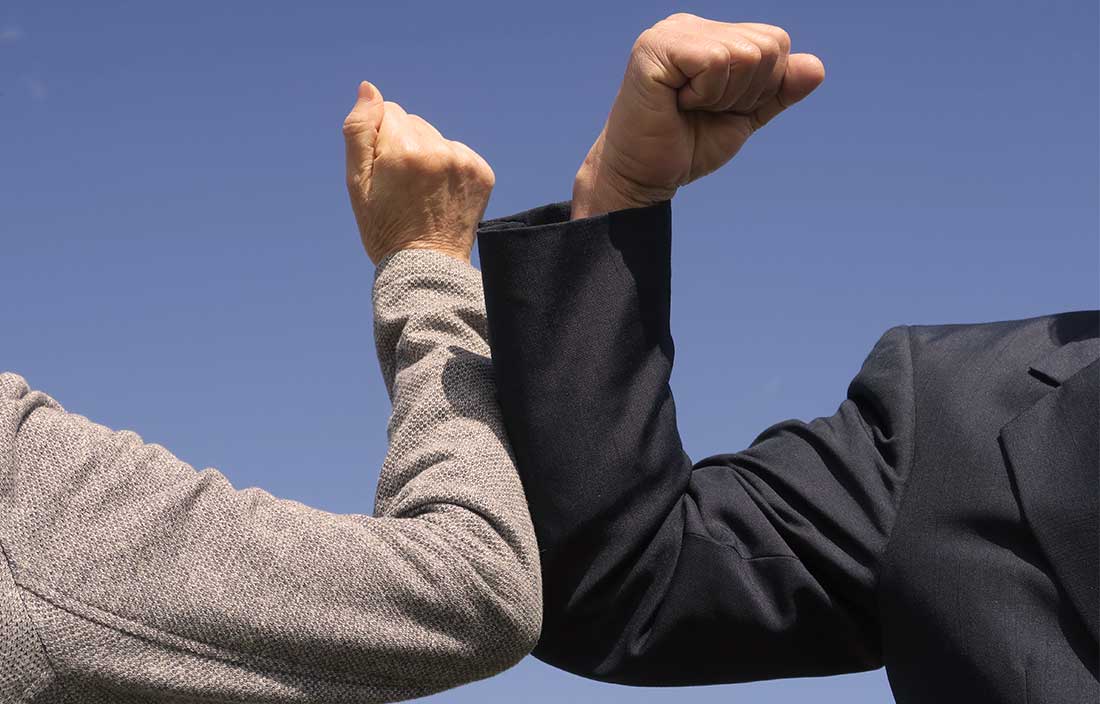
[480,198,691,677]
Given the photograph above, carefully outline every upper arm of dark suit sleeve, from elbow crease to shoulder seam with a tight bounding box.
[567,329,912,684]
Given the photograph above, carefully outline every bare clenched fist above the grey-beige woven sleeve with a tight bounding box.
[343,81,495,264]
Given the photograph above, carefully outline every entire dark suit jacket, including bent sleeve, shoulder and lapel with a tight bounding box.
[479,201,1100,704]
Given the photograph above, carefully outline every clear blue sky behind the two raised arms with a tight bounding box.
[0,0,1100,704]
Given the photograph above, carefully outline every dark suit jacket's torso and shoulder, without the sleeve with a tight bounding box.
[880,311,1100,702]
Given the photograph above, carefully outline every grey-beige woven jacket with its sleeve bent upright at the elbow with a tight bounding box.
[0,251,541,704]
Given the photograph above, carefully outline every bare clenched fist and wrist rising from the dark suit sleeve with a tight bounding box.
[573,13,825,219]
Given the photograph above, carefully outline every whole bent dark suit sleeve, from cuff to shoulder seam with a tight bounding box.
[480,202,914,684]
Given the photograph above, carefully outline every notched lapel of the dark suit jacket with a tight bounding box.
[1001,338,1100,640]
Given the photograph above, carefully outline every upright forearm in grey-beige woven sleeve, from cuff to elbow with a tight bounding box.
[374,250,541,660]
